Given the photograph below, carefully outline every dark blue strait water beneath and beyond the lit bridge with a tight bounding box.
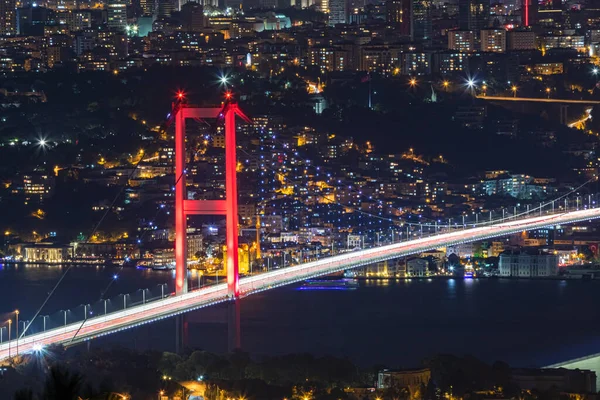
[0,266,600,367]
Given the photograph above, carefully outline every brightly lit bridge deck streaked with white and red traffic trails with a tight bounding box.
[0,208,600,360]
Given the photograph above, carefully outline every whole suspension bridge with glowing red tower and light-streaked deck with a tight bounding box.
[0,99,600,360]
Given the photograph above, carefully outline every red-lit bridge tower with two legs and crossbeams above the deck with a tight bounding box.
[174,102,250,297]
